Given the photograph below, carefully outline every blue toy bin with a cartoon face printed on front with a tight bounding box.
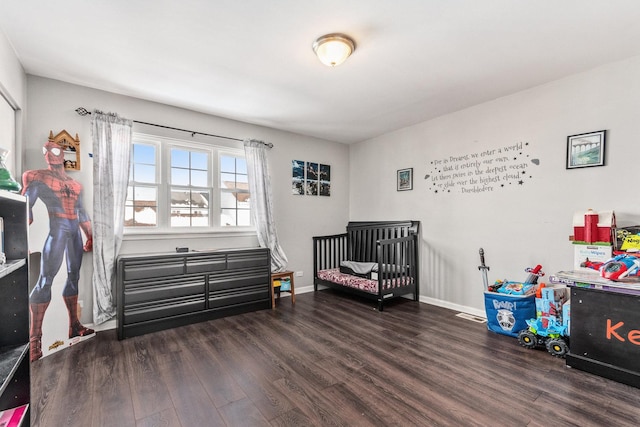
[484,291,536,337]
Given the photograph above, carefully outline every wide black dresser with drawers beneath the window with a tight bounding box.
[116,248,271,339]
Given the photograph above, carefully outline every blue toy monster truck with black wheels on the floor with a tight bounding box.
[518,317,569,358]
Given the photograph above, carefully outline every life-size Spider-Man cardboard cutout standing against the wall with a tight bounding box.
[22,141,95,362]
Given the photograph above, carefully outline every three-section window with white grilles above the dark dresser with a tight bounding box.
[125,133,251,232]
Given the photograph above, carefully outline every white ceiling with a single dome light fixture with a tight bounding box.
[0,0,640,143]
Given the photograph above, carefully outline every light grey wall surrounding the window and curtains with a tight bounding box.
[24,76,349,321]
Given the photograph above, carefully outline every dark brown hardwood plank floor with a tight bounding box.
[31,291,640,427]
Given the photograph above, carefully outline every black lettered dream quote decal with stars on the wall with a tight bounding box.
[424,142,540,194]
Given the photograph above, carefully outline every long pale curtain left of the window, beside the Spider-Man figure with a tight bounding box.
[91,111,133,325]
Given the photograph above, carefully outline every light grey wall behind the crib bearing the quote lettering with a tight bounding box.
[349,57,640,314]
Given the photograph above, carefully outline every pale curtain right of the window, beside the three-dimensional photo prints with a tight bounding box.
[244,139,288,273]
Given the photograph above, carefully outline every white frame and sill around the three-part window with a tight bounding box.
[124,132,255,236]
